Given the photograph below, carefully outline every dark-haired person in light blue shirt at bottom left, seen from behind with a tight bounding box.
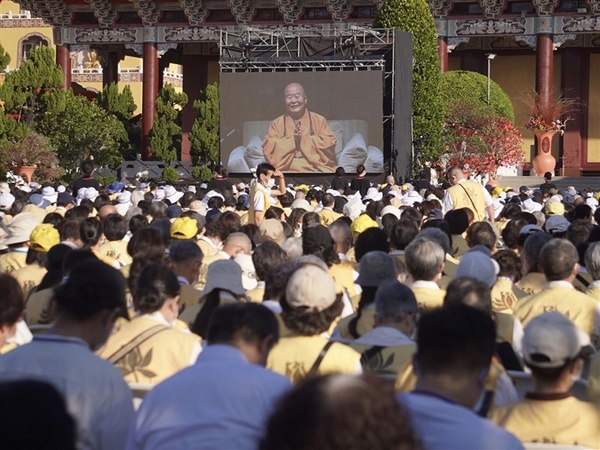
[0,260,133,450]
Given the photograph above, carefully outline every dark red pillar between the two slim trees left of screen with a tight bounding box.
[181,55,209,161]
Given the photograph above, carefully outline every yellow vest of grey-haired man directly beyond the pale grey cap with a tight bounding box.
[515,287,598,343]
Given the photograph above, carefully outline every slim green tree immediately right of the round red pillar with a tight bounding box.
[150,84,187,165]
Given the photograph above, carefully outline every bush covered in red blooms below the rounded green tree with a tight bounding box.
[444,105,524,174]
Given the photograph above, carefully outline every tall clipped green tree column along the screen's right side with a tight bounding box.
[374,0,443,160]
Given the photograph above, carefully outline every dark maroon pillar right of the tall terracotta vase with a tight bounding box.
[559,48,590,177]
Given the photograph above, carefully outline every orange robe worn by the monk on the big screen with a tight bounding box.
[263,110,336,172]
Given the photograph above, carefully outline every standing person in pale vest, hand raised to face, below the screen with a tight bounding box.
[248,163,285,226]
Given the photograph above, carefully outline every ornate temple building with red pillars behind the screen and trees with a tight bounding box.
[0,0,600,176]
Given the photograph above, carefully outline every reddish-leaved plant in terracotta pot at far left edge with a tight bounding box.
[0,133,65,182]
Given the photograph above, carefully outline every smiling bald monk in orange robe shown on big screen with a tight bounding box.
[263,83,336,172]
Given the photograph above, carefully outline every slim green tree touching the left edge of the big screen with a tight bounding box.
[190,83,219,180]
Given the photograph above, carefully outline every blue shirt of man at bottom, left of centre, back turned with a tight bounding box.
[127,344,291,450]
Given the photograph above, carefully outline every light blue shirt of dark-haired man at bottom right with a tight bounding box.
[397,391,523,450]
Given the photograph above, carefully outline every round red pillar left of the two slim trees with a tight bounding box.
[142,42,158,160]
